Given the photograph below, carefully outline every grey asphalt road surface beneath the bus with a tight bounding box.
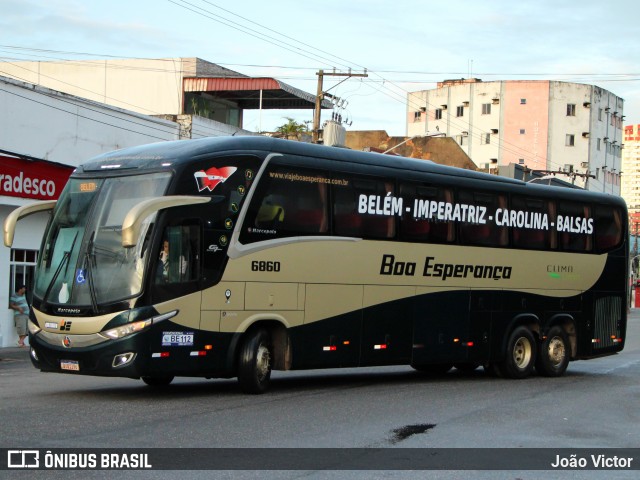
[0,310,640,479]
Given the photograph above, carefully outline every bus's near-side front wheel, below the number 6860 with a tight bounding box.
[238,329,273,394]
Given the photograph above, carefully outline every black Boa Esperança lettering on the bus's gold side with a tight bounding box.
[380,254,513,282]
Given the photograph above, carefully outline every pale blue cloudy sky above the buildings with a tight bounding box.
[0,0,640,135]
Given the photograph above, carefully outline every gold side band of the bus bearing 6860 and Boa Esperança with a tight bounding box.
[224,240,607,294]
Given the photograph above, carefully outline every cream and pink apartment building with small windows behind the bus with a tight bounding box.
[407,78,624,195]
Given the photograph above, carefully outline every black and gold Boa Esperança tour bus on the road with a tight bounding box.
[4,136,629,393]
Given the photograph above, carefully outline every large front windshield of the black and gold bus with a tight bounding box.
[34,173,171,308]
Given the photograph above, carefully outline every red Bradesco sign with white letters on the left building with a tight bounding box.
[0,155,73,200]
